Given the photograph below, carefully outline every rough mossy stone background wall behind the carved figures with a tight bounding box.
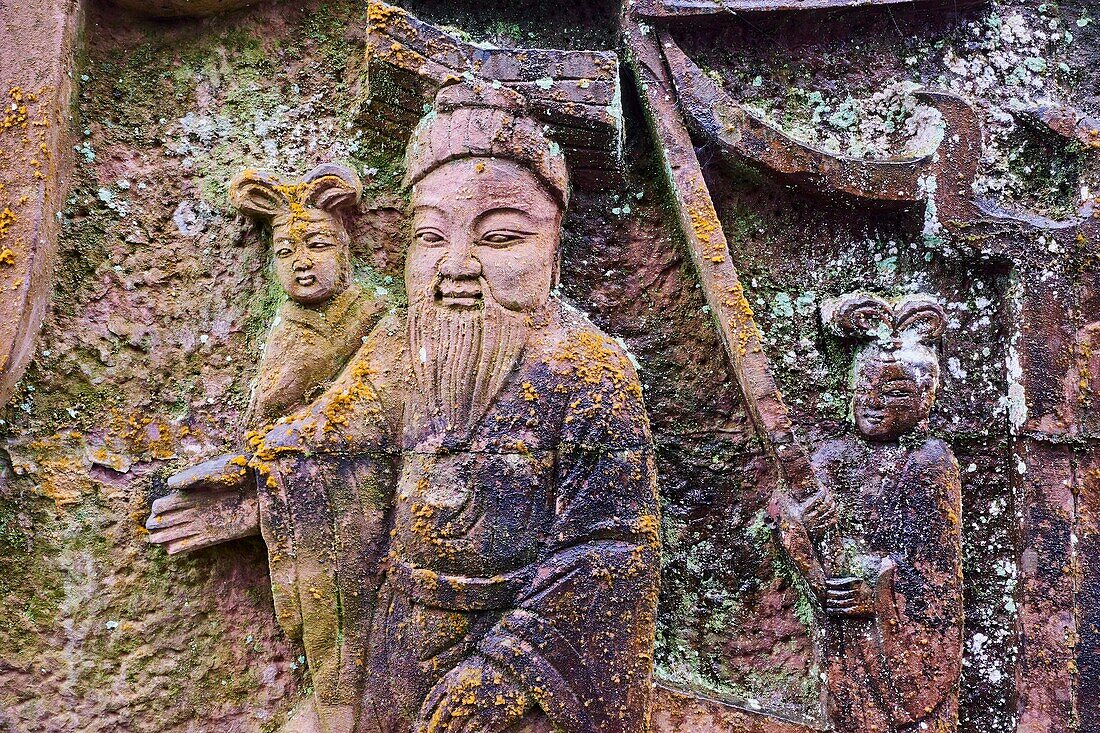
[0,0,1100,732]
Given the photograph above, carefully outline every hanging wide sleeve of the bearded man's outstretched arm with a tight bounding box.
[250,343,395,733]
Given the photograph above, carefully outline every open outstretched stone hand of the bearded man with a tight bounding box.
[145,455,260,555]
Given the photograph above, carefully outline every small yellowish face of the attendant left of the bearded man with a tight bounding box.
[272,209,350,306]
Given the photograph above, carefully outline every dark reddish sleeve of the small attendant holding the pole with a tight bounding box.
[867,440,963,726]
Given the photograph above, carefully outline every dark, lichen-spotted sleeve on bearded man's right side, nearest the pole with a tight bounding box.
[479,332,660,733]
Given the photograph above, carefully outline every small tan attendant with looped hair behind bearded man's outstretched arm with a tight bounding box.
[229,164,385,427]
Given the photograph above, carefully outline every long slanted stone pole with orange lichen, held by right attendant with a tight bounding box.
[623,13,825,590]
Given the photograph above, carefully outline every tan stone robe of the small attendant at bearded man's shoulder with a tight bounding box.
[245,283,387,427]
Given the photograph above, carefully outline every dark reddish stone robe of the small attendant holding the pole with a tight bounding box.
[813,439,963,733]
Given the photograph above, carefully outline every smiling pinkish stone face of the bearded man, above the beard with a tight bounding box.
[405,157,562,313]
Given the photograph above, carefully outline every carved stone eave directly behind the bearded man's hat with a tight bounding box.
[360,0,623,184]
